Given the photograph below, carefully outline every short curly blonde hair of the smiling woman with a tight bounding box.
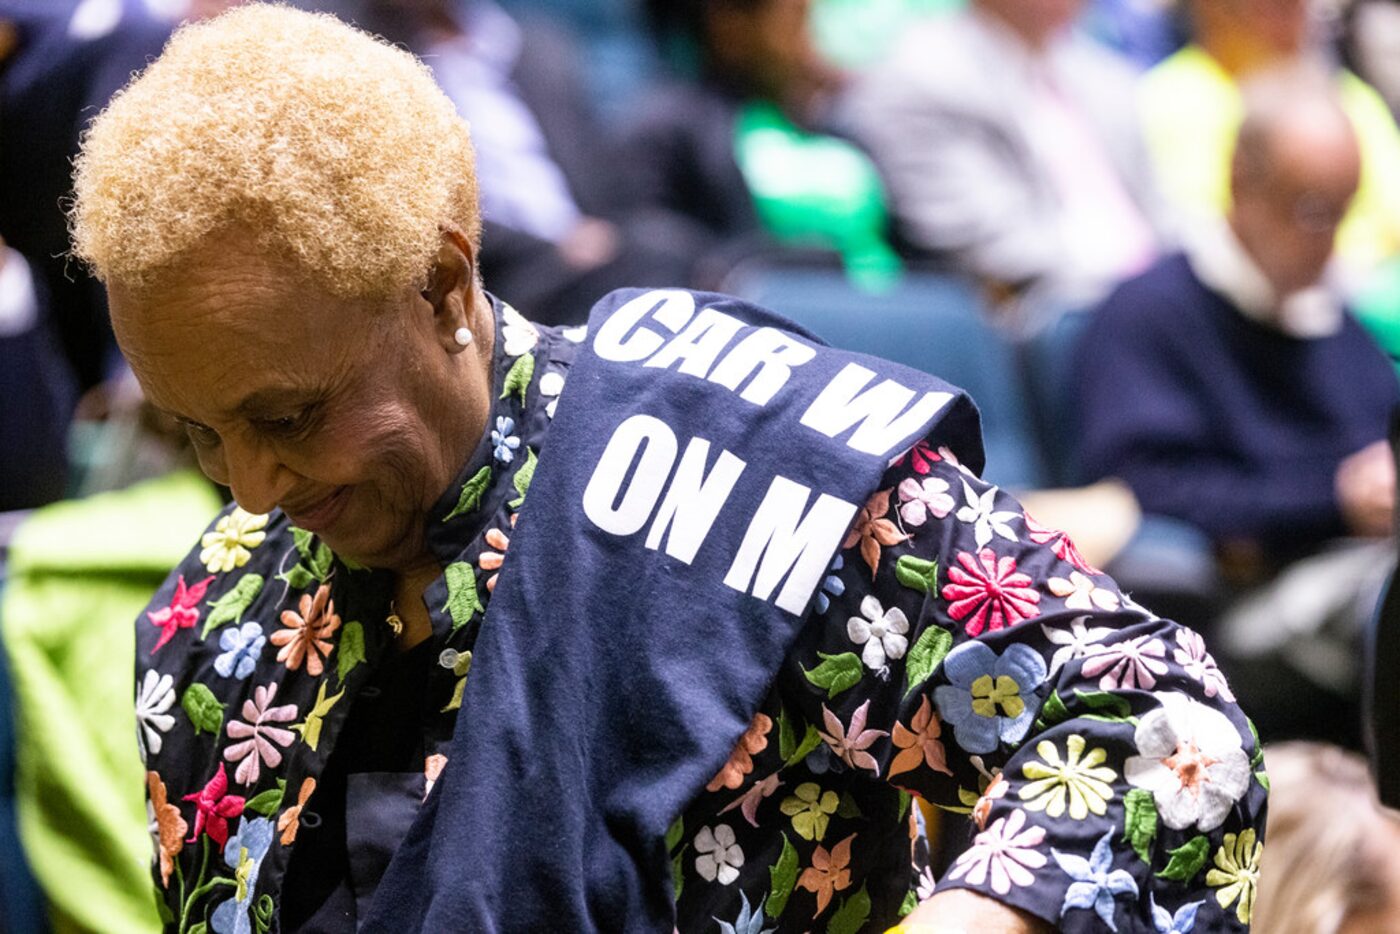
[69,3,480,298]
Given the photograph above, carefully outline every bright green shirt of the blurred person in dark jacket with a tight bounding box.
[735,101,900,290]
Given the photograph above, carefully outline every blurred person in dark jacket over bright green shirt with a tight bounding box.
[623,0,899,284]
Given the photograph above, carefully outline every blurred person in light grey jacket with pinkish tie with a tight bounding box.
[843,0,1165,326]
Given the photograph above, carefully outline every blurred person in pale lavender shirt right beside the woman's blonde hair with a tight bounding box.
[352,0,699,323]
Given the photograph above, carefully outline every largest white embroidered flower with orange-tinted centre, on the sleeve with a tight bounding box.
[1123,693,1250,833]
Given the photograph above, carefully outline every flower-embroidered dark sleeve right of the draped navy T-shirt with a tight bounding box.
[801,442,1267,933]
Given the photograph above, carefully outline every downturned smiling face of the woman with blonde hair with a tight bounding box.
[109,240,490,570]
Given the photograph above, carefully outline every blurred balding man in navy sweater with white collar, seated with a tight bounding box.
[1074,69,1400,742]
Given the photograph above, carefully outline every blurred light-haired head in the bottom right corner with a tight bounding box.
[1252,742,1400,934]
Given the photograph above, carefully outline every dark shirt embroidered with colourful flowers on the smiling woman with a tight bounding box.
[136,295,1267,934]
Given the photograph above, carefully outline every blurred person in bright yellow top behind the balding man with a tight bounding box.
[1141,0,1400,280]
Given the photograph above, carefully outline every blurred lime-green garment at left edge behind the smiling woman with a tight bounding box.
[0,471,221,934]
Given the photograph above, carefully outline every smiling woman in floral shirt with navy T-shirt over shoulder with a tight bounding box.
[73,4,1266,934]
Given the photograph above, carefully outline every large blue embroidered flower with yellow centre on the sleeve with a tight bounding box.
[934,641,1046,753]
